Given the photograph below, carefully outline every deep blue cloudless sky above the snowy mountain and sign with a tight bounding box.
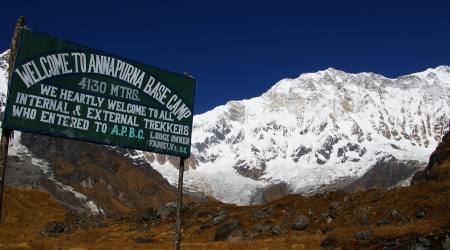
[0,0,450,113]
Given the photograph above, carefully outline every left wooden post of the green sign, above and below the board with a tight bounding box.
[0,16,25,223]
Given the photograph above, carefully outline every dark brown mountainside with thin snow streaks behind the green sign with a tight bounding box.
[0,49,187,214]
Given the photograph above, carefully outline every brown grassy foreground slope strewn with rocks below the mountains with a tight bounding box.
[0,133,450,249]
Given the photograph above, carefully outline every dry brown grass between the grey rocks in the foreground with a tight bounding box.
[0,177,450,250]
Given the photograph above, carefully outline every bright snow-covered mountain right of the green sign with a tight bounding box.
[152,66,450,204]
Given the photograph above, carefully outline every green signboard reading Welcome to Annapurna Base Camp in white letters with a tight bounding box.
[2,29,195,157]
